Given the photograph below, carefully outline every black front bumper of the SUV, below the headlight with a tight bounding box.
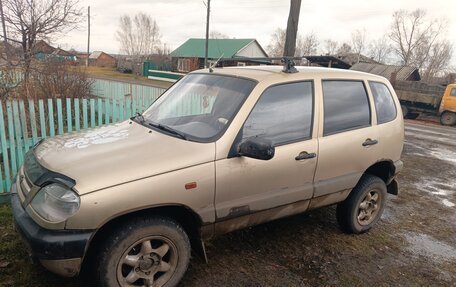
[11,193,94,277]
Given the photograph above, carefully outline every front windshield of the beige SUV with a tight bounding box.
[143,74,256,142]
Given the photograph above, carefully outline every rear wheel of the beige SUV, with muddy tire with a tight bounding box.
[336,174,386,234]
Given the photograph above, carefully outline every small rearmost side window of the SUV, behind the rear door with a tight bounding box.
[369,82,397,124]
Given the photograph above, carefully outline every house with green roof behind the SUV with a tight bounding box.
[170,38,269,72]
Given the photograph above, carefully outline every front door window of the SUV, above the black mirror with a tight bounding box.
[242,82,313,145]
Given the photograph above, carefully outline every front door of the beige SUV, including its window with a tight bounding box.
[215,81,318,229]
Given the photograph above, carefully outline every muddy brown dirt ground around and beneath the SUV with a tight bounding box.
[0,121,456,287]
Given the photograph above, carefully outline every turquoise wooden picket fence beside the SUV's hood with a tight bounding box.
[0,94,159,194]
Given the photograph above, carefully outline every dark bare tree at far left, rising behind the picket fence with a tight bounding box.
[3,0,82,80]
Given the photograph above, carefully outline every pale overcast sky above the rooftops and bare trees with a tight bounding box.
[54,0,456,63]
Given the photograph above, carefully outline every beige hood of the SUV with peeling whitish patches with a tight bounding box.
[35,121,215,194]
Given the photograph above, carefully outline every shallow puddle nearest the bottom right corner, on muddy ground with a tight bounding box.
[405,234,456,260]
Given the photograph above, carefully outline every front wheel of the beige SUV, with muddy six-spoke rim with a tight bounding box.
[97,217,191,287]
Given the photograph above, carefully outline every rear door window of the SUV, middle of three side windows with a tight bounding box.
[323,80,370,136]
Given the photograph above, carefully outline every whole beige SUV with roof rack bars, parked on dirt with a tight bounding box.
[12,66,404,286]
